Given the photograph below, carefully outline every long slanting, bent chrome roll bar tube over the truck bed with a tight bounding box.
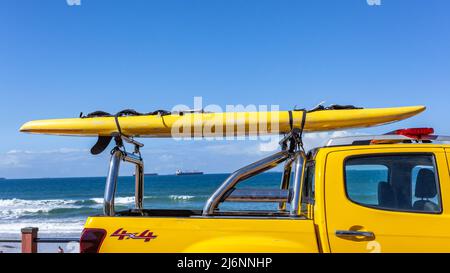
[203,151,290,216]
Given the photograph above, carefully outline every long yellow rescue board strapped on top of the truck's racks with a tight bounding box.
[20,106,426,137]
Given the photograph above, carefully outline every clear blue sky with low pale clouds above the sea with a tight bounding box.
[0,0,450,178]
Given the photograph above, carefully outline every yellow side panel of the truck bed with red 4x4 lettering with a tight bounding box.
[85,217,318,253]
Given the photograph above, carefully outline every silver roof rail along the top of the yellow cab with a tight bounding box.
[325,134,450,147]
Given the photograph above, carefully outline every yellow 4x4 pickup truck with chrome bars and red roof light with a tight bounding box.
[80,128,450,253]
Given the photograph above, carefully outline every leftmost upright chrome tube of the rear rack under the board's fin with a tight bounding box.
[103,150,123,216]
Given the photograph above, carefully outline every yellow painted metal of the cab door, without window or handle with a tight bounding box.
[324,145,450,252]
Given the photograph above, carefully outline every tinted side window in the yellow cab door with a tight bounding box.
[344,154,442,213]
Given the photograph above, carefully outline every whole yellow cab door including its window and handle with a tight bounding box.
[325,146,450,252]
